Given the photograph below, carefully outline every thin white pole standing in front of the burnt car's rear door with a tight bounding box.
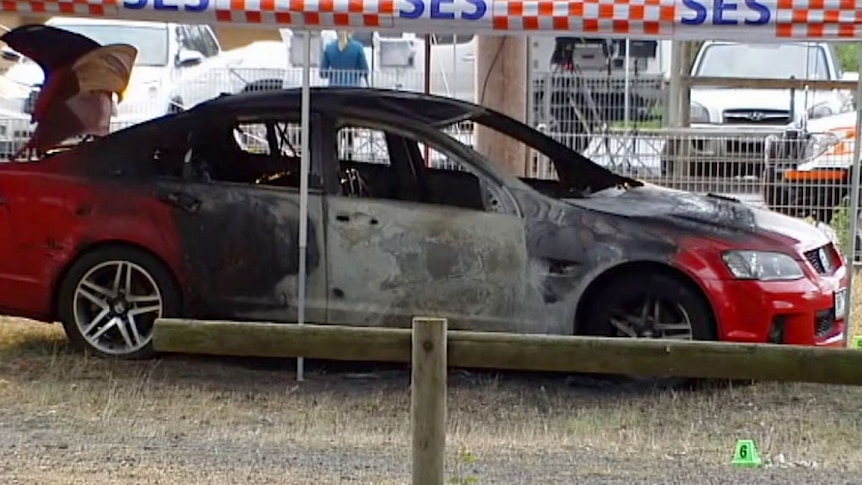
[296,30,311,381]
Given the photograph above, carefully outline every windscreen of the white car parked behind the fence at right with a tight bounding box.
[695,44,829,79]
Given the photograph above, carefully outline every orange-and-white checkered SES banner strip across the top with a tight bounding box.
[0,0,862,42]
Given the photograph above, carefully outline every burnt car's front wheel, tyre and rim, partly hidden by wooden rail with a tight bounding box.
[582,273,717,387]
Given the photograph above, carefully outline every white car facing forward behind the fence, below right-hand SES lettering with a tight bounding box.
[663,41,855,177]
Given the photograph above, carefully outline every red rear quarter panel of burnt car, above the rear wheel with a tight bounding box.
[0,170,185,320]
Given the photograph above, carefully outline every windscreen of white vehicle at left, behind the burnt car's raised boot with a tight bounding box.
[42,24,168,66]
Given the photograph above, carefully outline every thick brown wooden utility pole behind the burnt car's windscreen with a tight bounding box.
[475,35,530,177]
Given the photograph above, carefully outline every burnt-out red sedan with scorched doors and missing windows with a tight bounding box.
[0,87,848,358]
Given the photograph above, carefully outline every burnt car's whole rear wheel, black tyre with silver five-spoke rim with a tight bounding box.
[57,246,182,359]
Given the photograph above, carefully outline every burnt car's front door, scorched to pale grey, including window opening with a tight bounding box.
[321,115,527,331]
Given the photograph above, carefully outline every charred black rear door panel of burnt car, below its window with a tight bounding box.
[151,180,326,323]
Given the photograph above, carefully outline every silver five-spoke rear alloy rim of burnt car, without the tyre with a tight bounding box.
[73,261,164,355]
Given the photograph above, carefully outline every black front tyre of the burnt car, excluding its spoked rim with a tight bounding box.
[579,272,718,388]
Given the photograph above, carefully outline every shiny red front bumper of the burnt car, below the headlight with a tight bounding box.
[709,267,850,347]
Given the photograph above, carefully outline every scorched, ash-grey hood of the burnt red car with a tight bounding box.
[568,185,829,251]
